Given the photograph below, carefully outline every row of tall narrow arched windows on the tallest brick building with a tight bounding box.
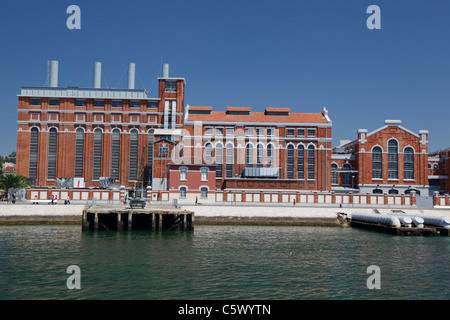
[28,127,155,181]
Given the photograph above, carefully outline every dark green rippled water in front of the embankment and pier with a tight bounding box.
[0,226,450,300]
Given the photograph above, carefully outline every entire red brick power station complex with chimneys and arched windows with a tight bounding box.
[16,61,449,199]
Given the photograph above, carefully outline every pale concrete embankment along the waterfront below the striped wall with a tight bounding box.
[0,203,450,226]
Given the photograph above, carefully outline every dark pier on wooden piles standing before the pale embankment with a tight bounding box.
[82,205,194,231]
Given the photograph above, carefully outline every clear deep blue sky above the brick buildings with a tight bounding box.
[0,0,450,155]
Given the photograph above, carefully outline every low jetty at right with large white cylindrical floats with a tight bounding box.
[338,213,450,236]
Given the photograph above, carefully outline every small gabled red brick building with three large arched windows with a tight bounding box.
[331,120,429,195]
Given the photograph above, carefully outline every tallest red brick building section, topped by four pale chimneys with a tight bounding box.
[16,62,185,188]
